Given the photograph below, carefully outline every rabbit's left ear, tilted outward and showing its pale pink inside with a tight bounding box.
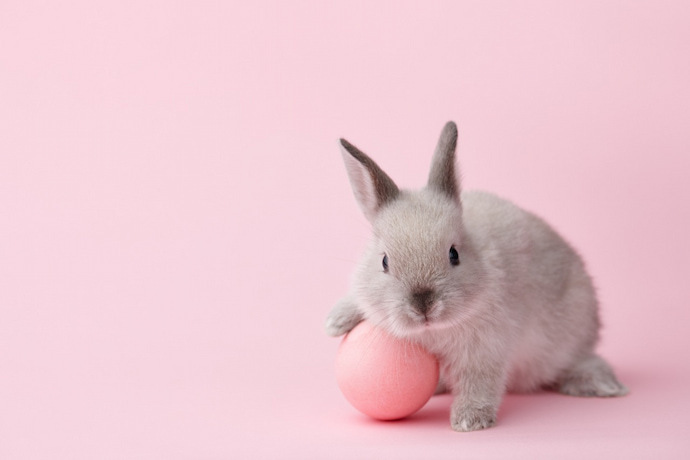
[340,139,400,222]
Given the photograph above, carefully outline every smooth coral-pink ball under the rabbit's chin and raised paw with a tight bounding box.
[335,321,439,420]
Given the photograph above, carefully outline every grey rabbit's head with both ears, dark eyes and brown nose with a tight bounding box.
[340,122,480,336]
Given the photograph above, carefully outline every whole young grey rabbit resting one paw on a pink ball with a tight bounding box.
[326,121,628,432]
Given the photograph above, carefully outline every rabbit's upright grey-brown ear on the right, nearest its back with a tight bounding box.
[427,121,460,202]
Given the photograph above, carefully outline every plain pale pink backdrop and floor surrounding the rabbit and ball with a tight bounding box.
[0,0,690,459]
